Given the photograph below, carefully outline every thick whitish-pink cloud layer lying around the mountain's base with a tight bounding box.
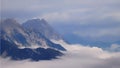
[0,40,120,68]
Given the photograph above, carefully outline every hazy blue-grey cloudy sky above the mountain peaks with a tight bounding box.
[0,0,120,41]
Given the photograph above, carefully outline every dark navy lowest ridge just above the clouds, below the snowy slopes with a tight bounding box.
[0,39,63,61]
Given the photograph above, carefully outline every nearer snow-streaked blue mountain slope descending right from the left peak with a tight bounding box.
[0,19,65,51]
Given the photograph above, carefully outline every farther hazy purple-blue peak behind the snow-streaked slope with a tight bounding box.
[23,19,62,40]
